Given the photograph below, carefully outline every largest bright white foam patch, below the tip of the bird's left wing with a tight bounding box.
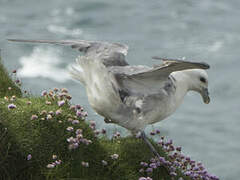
[18,47,71,83]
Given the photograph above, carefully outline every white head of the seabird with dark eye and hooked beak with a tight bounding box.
[183,69,210,104]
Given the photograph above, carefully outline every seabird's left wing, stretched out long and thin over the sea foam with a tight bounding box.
[8,39,128,66]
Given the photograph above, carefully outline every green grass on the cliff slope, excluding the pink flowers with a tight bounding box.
[0,55,189,180]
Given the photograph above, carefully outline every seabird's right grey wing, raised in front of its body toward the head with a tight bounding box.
[115,59,209,94]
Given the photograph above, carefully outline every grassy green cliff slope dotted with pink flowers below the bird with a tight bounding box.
[0,55,218,180]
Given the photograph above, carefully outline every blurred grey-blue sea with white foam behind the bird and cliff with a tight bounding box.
[0,0,240,180]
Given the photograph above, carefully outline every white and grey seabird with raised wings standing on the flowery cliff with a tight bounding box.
[8,39,210,157]
